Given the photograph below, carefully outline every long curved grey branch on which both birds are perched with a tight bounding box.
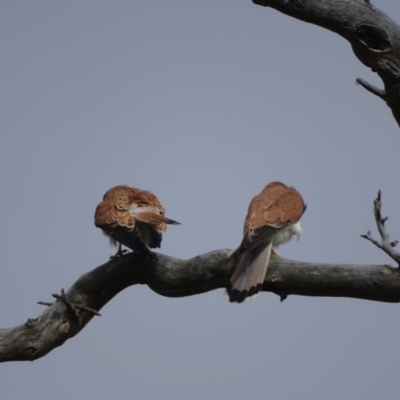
[0,250,400,362]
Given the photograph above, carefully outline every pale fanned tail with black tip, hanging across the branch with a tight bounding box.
[226,242,272,303]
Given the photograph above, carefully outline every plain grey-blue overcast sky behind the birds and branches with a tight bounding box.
[0,0,400,400]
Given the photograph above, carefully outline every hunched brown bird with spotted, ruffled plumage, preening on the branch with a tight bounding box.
[94,185,179,261]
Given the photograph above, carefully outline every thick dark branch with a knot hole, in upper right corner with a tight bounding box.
[253,0,400,125]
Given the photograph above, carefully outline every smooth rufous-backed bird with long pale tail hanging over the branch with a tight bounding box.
[221,182,307,303]
